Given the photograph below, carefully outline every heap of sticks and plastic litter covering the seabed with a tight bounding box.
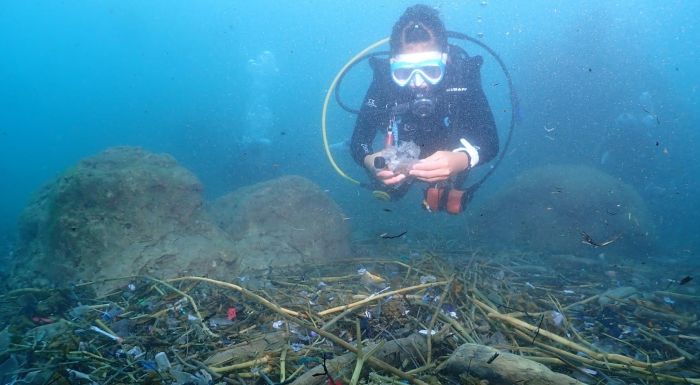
[0,253,700,385]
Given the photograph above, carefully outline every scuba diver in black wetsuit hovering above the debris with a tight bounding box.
[350,5,499,214]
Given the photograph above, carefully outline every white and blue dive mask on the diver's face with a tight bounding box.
[390,51,447,87]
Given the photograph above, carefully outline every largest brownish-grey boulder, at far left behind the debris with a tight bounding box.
[13,147,238,285]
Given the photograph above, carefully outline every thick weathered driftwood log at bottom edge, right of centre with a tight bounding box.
[438,343,583,385]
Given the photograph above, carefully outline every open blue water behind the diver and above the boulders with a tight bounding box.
[0,0,700,255]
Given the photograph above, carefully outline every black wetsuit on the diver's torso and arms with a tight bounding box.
[350,45,498,195]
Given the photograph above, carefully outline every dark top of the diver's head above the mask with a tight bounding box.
[389,4,447,55]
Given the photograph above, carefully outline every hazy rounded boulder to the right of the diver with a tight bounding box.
[472,165,655,257]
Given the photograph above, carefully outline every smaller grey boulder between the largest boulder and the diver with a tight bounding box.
[211,176,350,270]
